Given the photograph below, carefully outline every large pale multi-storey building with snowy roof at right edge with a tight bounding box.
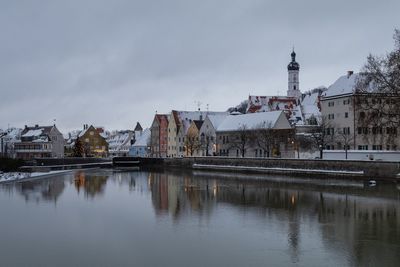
[321,72,400,151]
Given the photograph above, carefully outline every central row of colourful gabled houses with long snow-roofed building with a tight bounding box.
[150,110,294,157]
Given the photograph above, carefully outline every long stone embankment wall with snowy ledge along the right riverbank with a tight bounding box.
[135,157,400,181]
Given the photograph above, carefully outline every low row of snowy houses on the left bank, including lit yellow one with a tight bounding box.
[0,123,149,160]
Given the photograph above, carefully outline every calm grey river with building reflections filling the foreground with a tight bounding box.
[0,170,400,267]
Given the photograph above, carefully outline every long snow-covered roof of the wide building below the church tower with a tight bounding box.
[217,111,290,132]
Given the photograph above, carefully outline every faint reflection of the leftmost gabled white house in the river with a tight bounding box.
[16,178,65,203]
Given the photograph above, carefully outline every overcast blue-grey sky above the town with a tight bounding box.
[0,0,400,131]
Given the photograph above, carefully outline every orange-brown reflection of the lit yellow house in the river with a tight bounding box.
[74,171,108,197]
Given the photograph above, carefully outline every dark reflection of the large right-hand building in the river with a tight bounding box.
[316,194,400,266]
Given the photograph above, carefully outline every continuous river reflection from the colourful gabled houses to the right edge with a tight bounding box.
[148,173,400,265]
